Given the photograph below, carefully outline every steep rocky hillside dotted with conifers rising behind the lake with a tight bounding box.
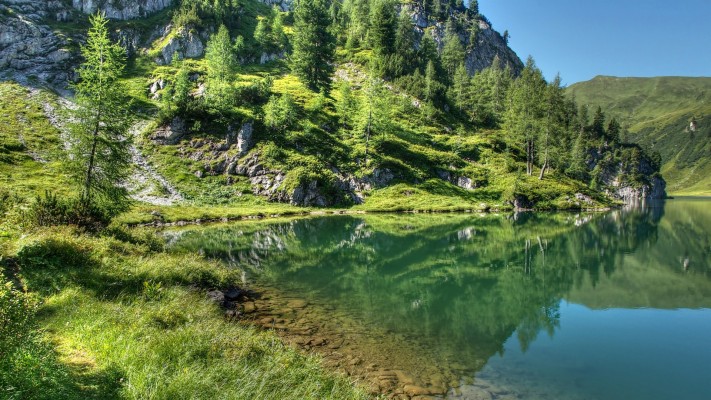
[0,0,664,219]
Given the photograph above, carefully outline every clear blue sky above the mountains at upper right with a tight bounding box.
[479,0,711,84]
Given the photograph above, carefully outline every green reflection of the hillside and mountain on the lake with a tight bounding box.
[168,202,711,378]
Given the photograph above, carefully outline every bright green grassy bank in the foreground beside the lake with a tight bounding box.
[0,228,366,399]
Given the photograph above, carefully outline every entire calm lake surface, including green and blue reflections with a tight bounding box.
[169,199,711,399]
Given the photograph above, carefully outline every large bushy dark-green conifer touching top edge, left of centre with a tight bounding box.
[291,0,336,91]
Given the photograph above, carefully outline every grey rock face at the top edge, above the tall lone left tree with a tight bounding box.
[72,0,173,20]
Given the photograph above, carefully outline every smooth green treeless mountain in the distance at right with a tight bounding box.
[567,76,711,195]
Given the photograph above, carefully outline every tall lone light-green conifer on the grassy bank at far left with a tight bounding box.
[68,14,131,215]
